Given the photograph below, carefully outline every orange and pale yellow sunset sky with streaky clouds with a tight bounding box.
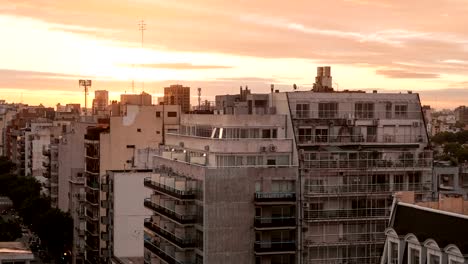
[0,0,468,108]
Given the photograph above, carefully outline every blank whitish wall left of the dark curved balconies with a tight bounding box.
[111,172,151,257]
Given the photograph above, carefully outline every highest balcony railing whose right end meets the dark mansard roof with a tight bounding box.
[304,208,390,221]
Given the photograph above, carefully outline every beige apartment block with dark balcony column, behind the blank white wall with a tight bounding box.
[84,104,180,263]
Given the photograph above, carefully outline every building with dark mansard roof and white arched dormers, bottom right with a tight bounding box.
[380,194,468,264]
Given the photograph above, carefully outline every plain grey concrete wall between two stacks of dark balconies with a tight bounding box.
[203,168,296,264]
